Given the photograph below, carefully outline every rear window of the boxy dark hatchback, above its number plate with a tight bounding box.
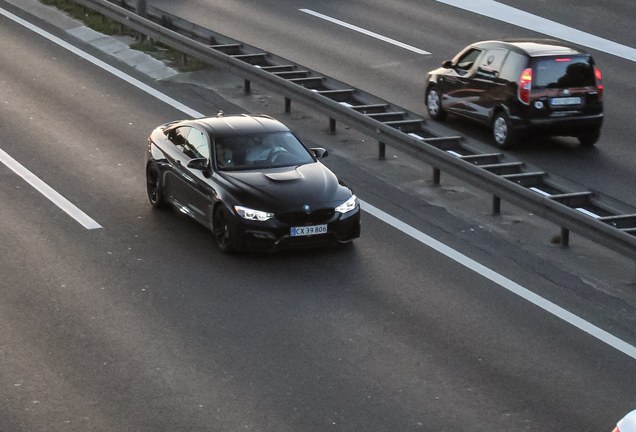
[532,57,596,88]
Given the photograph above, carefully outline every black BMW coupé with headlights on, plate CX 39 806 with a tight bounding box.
[146,115,360,252]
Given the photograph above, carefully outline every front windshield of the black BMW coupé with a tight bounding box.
[214,132,314,171]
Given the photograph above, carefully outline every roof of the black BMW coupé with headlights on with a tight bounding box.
[193,114,289,138]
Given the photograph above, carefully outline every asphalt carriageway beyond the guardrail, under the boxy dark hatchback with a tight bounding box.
[148,0,636,206]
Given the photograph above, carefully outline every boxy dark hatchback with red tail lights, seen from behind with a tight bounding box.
[426,39,603,148]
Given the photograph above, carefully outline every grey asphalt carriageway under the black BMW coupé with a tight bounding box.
[0,2,636,432]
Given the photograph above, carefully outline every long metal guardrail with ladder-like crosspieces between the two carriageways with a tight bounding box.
[74,0,636,260]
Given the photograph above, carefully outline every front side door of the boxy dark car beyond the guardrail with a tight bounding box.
[439,48,483,115]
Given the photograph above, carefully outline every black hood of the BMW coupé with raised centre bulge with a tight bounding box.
[217,162,351,212]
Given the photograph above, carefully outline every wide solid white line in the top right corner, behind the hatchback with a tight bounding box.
[437,0,636,61]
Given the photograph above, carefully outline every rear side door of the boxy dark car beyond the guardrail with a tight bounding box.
[467,48,508,123]
